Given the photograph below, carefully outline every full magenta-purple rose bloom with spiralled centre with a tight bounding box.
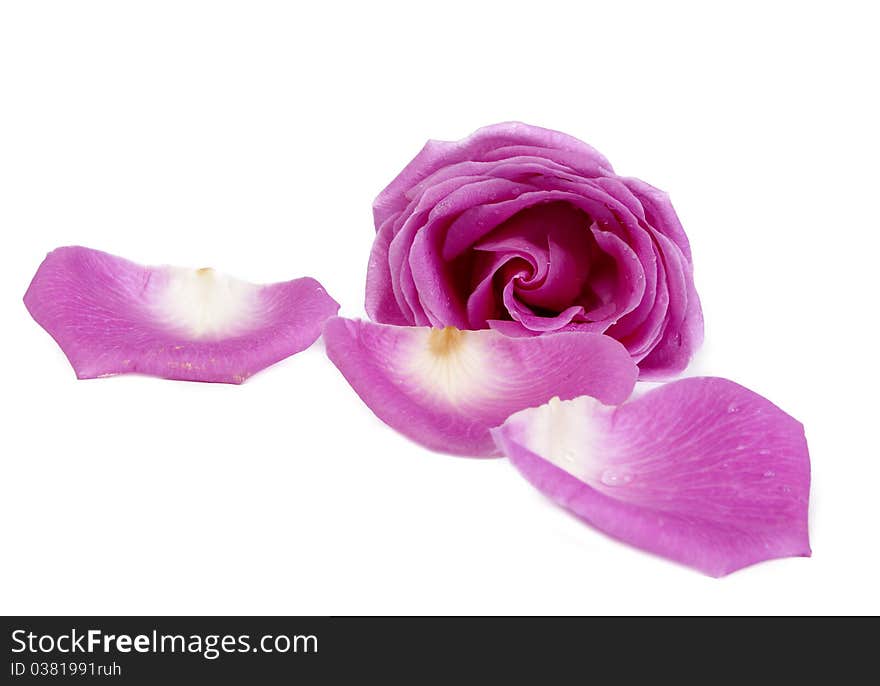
[366,123,703,378]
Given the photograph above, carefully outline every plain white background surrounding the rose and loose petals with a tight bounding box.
[0,0,880,614]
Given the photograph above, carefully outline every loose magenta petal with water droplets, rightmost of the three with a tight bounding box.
[493,377,810,576]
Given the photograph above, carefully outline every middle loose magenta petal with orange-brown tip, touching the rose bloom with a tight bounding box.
[324,317,638,456]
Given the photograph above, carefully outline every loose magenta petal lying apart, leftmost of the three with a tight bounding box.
[24,247,339,383]
